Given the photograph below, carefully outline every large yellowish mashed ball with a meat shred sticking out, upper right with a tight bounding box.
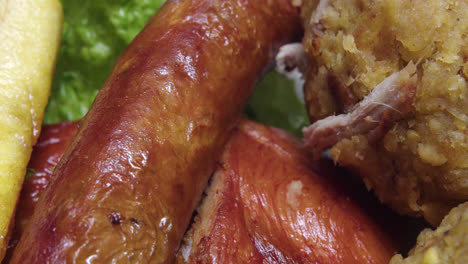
[303,0,468,224]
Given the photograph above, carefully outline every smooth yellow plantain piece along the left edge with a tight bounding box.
[0,0,63,262]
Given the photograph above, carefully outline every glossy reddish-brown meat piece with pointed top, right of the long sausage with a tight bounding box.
[178,121,396,264]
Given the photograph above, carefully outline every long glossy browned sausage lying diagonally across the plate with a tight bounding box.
[12,0,300,263]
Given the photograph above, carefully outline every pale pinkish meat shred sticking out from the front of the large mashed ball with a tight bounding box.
[303,62,417,158]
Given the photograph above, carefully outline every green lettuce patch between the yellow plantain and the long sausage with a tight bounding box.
[44,0,164,124]
